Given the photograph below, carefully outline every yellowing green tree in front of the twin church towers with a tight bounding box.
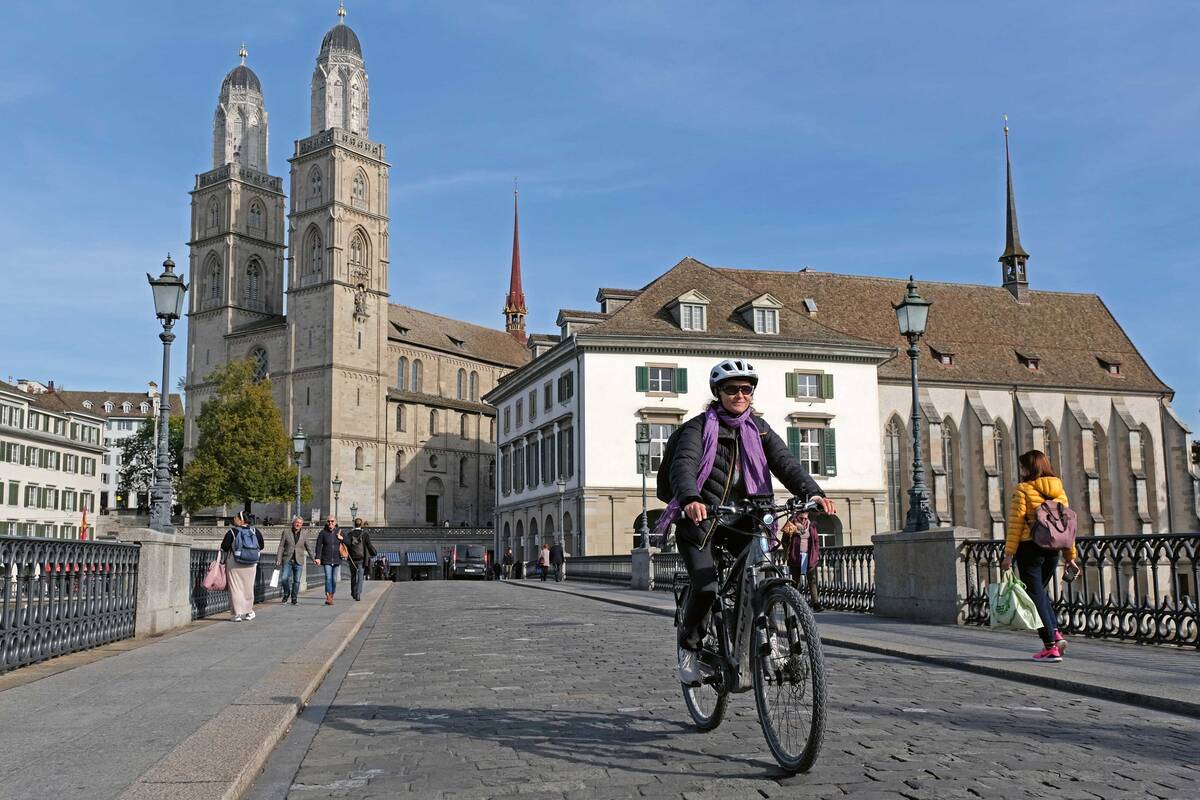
[179,359,312,513]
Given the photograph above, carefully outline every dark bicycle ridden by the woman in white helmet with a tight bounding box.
[674,497,826,772]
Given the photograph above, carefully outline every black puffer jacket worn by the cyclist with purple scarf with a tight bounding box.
[671,414,824,513]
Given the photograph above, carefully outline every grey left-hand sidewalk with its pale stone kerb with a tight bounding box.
[0,582,391,800]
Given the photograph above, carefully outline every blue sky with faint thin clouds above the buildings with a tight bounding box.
[0,0,1200,427]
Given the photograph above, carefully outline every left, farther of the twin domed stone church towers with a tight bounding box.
[185,44,286,462]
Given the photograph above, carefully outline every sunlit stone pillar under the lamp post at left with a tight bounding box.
[121,528,192,636]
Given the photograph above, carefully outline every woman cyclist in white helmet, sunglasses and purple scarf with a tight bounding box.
[660,359,835,686]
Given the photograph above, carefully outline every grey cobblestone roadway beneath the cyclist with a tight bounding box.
[276,582,1200,800]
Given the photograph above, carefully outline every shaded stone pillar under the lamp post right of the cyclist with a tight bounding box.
[871,527,980,625]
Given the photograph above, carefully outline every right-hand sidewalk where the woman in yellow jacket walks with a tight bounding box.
[510,581,1200,717]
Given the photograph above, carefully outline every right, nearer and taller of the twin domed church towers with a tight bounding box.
[286,7,389,522]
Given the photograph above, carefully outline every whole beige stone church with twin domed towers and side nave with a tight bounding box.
[185,12,529,525]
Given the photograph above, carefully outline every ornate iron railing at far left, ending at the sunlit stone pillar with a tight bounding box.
[0,536,138,673]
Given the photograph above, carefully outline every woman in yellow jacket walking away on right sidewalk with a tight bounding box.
[1000,450,1075,662]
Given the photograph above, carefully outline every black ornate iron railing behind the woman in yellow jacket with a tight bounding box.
[959,534,1200,648]
